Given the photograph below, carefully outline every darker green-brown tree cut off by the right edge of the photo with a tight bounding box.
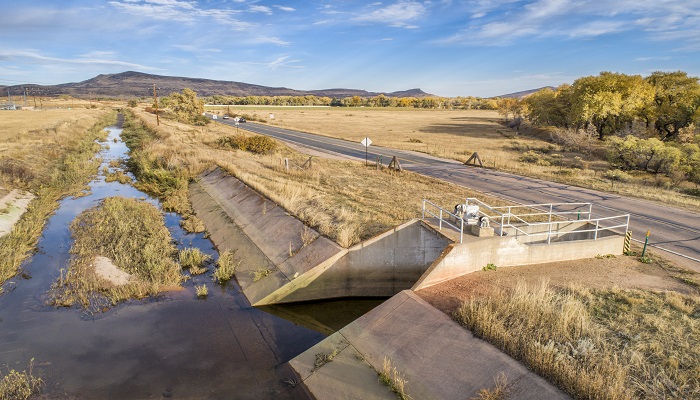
[646,71,700,140]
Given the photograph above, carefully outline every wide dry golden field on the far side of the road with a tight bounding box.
[205,106,700,211]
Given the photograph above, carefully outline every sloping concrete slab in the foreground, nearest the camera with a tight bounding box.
[289,291,569,400]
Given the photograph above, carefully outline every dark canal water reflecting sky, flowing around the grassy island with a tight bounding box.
[0,118,381,399]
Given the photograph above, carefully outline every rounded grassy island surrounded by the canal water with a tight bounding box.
[49,197,181,312]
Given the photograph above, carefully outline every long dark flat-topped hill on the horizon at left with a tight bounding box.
[0,71,432,98]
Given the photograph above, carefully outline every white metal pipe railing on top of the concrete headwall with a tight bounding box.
[422,197,630,244]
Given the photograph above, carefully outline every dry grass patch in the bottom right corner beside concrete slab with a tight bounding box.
[455,281,700,399]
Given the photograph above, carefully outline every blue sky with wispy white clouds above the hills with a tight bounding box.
[0,0,700,97]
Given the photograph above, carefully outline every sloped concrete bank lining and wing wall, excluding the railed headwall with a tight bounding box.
[190,168,450,306]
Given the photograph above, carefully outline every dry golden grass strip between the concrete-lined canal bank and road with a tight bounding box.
[125,111,501,246]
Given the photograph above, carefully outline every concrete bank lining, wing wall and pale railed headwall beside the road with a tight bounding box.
[190,168,627,306]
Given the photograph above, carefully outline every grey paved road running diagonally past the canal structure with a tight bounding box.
[219,120,700,272]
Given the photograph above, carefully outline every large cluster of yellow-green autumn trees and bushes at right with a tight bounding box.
[506,71,700,183]
